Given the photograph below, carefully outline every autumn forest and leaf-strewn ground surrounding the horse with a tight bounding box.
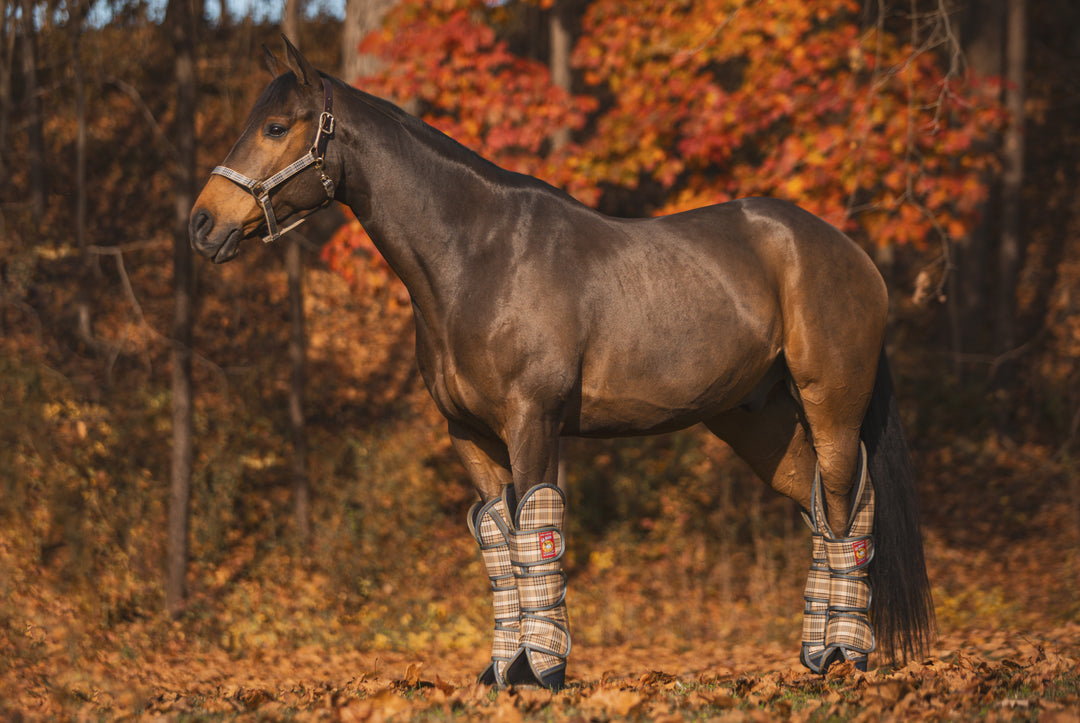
[0,0,1080,720]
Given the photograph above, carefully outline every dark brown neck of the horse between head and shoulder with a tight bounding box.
[343,87,501,319]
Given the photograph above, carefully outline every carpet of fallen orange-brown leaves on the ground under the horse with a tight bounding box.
[29,635,1080,723]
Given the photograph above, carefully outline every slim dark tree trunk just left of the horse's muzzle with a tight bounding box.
[165,0,202,617]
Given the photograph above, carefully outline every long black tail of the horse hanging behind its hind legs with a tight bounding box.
[862,349,934,660]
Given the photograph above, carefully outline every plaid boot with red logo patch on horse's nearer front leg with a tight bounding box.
[505,484,570,691]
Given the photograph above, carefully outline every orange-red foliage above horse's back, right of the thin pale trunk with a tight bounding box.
[576,1,996,243]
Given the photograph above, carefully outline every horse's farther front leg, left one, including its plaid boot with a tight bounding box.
[449,424,521,687]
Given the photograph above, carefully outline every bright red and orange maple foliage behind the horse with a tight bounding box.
[325,0,1003,283]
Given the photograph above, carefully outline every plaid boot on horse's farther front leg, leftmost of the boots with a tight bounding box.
[467,497,521,687]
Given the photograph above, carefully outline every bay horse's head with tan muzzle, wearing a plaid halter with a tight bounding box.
[188,38,335,264]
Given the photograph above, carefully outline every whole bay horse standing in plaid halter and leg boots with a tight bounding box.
[189,38,934,689]
